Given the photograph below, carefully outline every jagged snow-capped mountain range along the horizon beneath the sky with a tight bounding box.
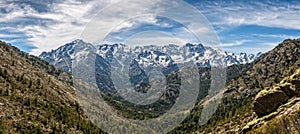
[39,39,262,72]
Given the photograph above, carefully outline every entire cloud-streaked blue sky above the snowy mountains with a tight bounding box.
[0,0,300,55]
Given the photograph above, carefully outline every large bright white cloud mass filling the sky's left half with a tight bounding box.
[0,0,188,55]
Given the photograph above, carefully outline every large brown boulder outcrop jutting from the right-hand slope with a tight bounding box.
[253,69,300,116]
